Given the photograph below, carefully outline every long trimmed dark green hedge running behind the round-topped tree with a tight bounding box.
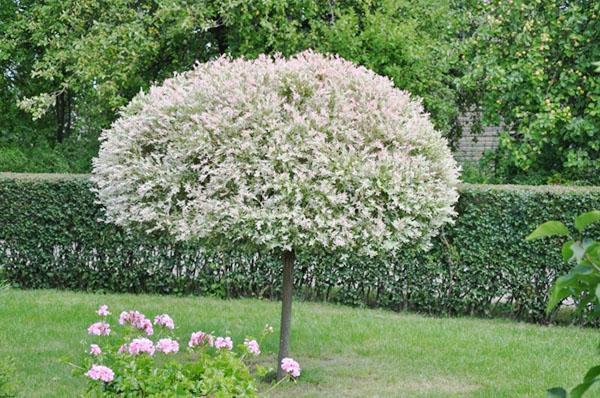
[0,174,600,323]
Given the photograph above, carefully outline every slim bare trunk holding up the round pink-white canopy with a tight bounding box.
[277,251,296,380]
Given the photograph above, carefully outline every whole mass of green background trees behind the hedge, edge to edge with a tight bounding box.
[0,0,600,184]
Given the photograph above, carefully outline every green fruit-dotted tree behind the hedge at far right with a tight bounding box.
[461,0,600,182]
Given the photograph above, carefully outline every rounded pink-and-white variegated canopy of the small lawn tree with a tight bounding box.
[92,51,458,256]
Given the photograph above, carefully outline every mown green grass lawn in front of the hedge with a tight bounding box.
[0,290,600,398]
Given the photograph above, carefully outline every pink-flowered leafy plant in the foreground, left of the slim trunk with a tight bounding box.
[77,305,300,397]
